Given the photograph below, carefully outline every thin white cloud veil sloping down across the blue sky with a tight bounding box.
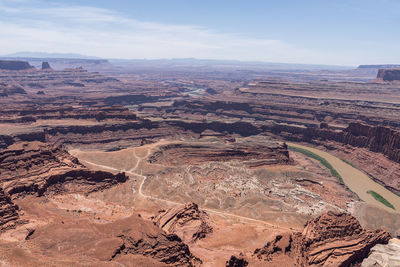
[0,0,356,64]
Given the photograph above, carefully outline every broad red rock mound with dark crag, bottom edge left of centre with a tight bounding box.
[29,214,201,266]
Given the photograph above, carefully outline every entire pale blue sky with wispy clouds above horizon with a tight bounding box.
[0,0,400,66]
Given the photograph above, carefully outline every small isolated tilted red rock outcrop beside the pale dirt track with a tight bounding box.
[153,203,213,243]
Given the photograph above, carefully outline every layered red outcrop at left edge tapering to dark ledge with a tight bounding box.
[0,142,127,198]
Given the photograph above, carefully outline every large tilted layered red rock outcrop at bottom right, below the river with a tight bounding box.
[254,212,390,266]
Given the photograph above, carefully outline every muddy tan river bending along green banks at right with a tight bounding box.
[287,142,400,212]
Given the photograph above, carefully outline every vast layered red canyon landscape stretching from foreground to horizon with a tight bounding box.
[0,59,400,266]
